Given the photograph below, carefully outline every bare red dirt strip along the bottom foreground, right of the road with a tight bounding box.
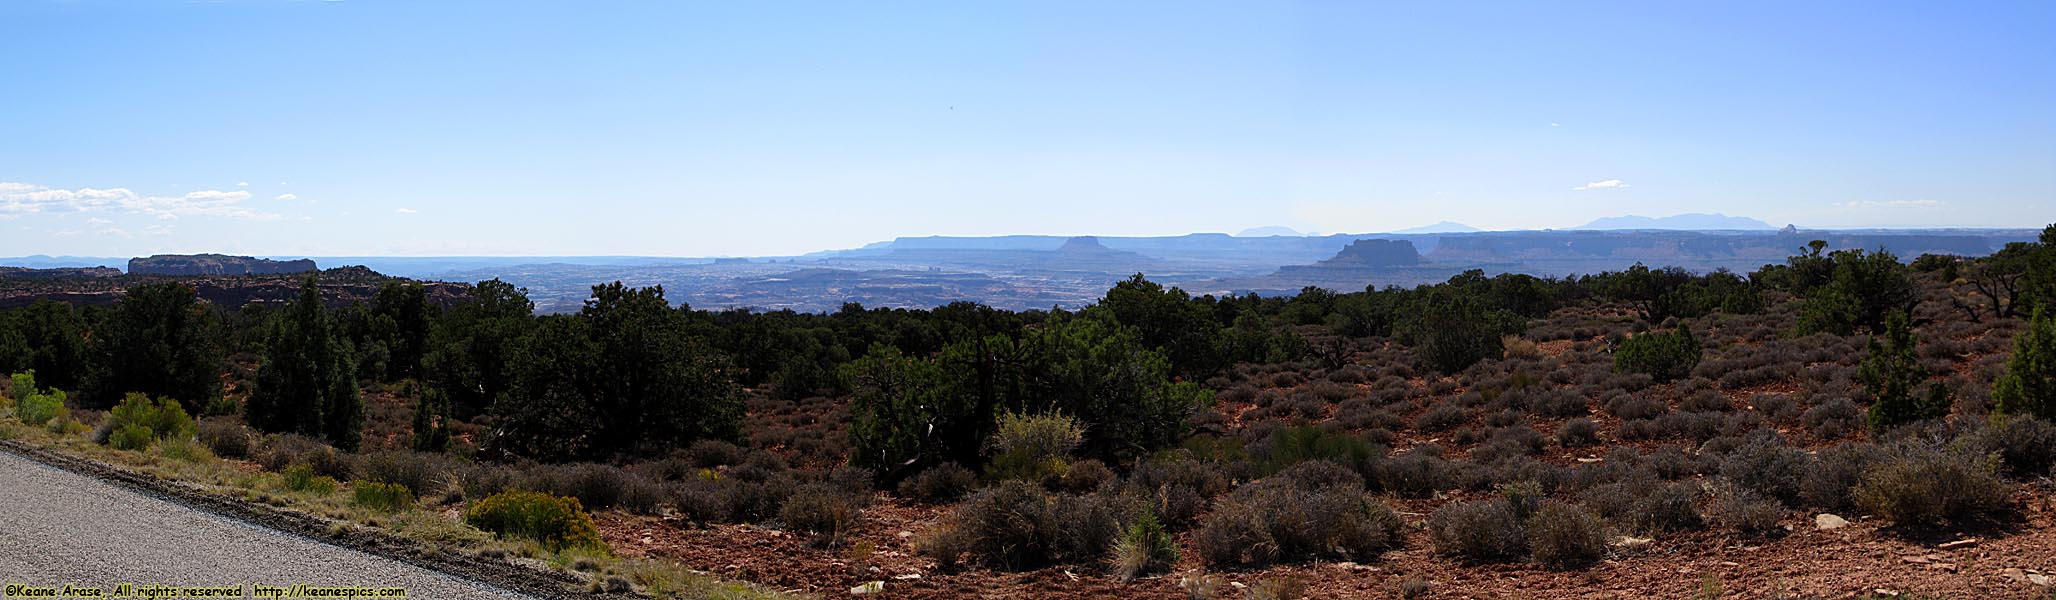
[598,493,2056,598]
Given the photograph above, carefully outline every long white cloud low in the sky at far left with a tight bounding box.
[0,181,280,220]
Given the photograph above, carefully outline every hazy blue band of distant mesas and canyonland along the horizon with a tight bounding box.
[0,214,2040,312]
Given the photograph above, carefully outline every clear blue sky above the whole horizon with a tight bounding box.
[0,0,2056,255]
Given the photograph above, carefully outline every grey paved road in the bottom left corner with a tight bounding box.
[0,452,528,598]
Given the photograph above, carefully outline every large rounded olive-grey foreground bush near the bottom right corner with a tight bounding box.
[1855,444,2011,524]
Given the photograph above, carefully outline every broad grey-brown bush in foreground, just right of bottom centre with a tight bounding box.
[1195,460,1400,565]
